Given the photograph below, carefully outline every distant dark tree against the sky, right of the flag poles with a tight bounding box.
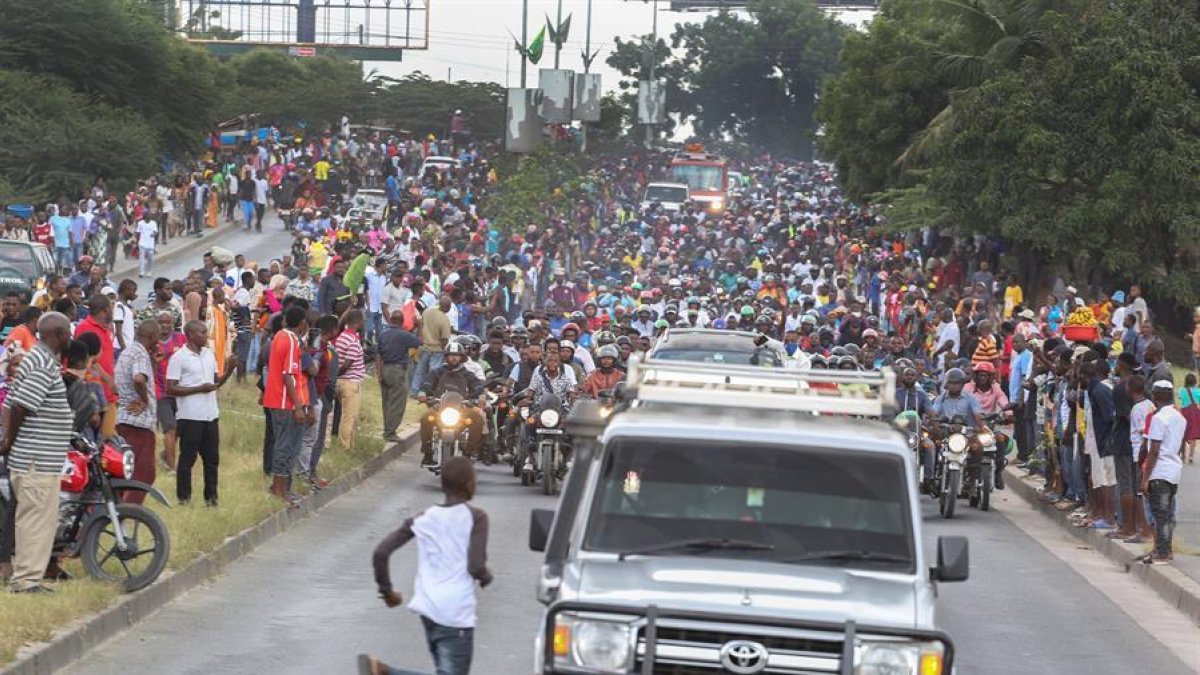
[607,0,847,159]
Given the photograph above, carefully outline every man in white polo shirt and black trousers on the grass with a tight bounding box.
[167,321,238,508]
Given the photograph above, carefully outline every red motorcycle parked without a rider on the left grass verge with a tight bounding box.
[54,435,170,592]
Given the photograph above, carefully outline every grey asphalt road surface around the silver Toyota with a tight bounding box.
[68,456,1200,675]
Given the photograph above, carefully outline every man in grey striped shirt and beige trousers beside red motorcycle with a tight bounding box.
[0,312,74,593]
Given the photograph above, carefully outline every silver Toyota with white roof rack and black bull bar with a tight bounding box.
[529,356,968,675]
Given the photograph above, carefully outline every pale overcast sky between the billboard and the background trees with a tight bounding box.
[367,0,870,90]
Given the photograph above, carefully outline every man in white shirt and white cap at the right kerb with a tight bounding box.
[1141,380,1188,565]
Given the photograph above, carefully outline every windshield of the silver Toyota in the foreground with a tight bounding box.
[584,438,914,572]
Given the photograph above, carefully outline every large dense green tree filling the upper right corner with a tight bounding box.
[820,0,1200,304]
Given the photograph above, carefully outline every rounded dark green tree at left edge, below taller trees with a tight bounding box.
[0,71,157,203]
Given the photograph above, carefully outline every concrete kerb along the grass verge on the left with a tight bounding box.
[0,428,418,675]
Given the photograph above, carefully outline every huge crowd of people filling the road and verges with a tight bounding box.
[0,124,1200,610]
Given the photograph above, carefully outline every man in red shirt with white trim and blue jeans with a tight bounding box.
[263,306,316,509]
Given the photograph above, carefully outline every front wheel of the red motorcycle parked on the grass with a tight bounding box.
[79,504,170,593]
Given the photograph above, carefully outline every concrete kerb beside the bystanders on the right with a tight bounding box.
[1004,461,1200,626]
